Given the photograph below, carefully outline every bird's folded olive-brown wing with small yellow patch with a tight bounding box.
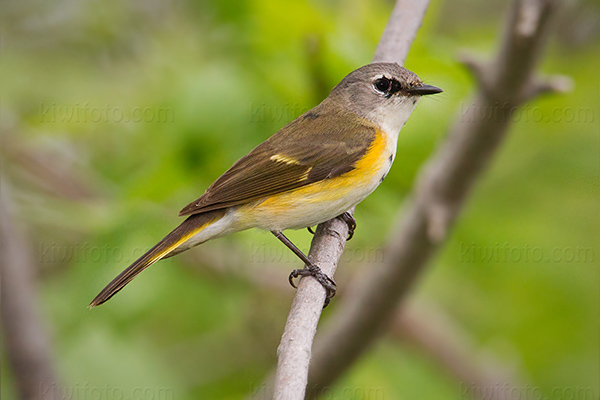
[179,103,376,216]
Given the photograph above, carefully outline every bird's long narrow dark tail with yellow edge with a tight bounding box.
[89,210,225,308]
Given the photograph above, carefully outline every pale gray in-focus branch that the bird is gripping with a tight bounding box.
[274,0,429,400]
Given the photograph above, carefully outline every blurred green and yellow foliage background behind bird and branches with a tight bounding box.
[0,0,600,399]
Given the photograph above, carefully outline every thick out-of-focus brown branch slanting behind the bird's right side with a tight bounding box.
[307,0,556,398]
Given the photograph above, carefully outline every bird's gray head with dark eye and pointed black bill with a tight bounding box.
[329,63,442,133]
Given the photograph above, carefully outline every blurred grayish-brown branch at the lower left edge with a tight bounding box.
[0,179,59,400]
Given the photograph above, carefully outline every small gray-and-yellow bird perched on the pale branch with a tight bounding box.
[89,63,442,308]
